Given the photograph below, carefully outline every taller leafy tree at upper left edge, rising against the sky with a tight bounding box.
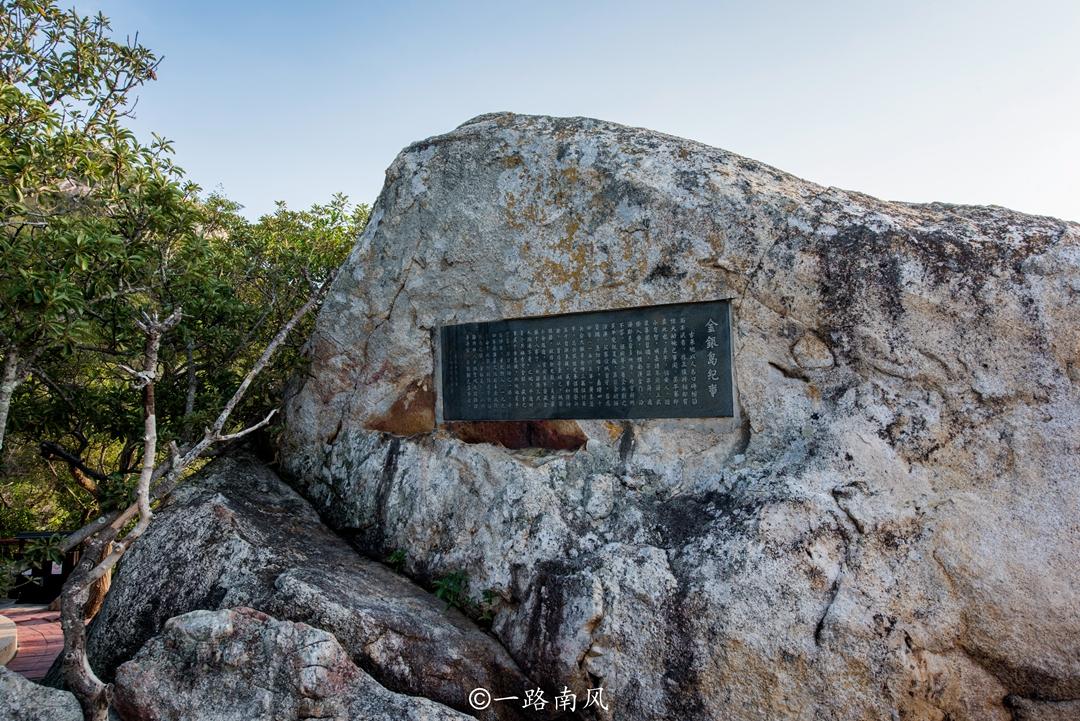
[0,0,168,450]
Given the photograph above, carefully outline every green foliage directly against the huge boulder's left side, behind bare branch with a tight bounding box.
[154,194,368,436]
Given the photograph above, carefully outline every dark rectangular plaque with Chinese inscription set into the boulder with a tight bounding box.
[440,300,734,421]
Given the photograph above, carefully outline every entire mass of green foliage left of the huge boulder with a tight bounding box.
[0,0,369,535]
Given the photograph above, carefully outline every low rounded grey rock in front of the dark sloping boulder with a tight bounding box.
[113,609,472,721]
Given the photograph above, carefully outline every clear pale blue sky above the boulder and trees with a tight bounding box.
[77,0,1080,220]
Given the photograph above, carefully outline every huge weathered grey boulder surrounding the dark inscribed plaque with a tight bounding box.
[283,114,1080,721]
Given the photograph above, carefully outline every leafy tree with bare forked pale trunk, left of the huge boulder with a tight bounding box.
[7,188,367,719]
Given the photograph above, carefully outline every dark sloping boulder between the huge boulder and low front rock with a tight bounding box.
[60,458,528,718]
